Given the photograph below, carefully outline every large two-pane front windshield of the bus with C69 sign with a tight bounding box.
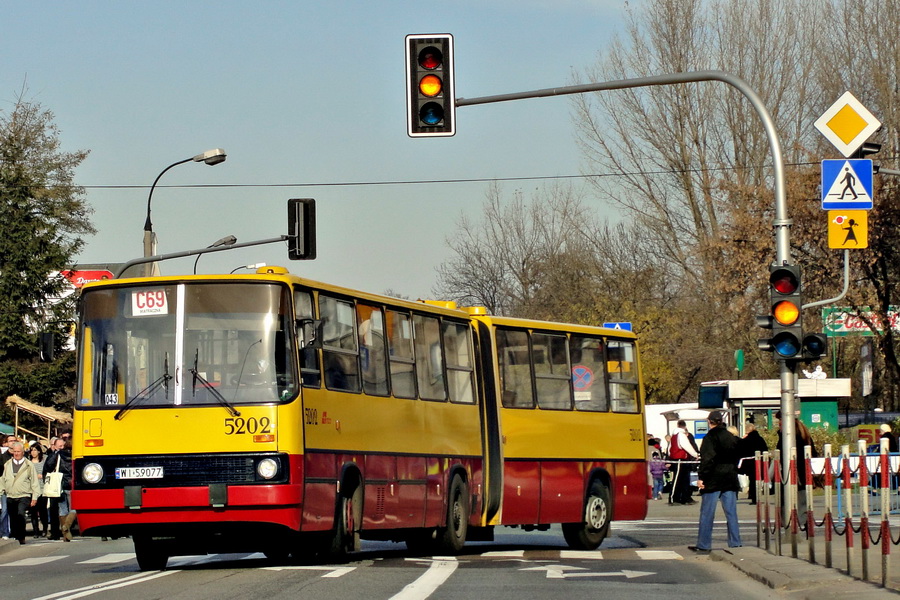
[77,282,298,408]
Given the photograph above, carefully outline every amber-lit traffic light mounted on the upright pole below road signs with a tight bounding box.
[756,265,803,359]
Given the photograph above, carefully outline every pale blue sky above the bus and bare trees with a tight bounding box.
[0,0,634,298]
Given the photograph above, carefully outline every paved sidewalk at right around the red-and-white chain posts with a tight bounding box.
[648,497,900,600]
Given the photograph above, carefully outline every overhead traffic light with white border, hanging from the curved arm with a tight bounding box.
[406,34,456,137]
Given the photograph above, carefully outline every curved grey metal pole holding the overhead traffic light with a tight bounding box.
[456,71,797,480]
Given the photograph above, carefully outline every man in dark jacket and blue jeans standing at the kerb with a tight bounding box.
[688,410,741,554]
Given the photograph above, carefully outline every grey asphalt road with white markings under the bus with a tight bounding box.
[0,506,773,600]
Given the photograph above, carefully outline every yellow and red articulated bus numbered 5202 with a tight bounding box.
[72,267,648,570]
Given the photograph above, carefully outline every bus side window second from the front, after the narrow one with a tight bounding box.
[319,294,359,392]
